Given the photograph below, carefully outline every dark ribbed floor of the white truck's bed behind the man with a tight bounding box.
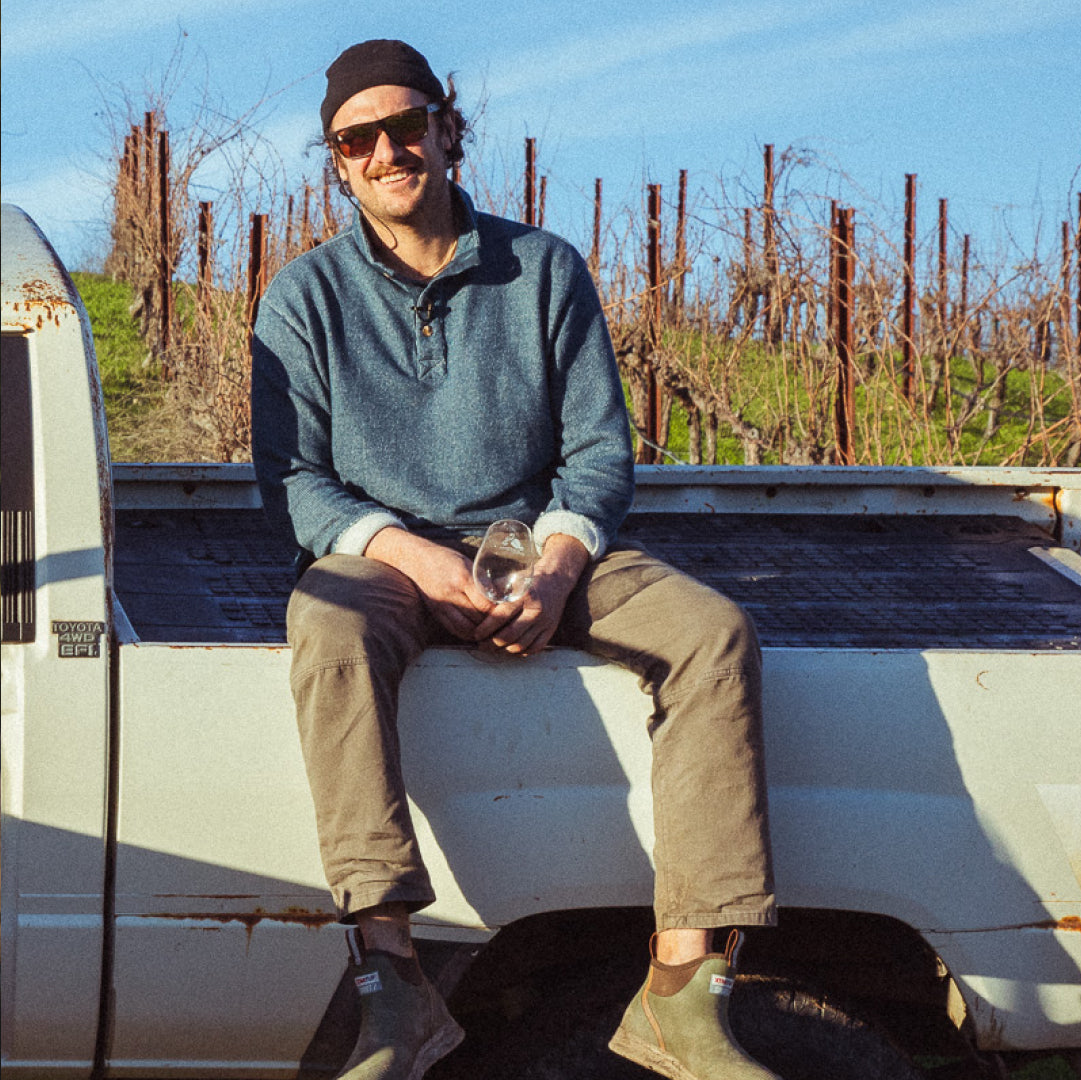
[116,509,1081,651]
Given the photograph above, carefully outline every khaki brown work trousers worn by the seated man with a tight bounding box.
[288,545,775,930]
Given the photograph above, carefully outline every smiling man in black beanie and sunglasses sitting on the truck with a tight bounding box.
[253,41,775,1080]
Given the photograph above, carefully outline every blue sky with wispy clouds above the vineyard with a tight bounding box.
[0,0,1081,270]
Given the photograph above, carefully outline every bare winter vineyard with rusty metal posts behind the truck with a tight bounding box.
[95,101,1081,466]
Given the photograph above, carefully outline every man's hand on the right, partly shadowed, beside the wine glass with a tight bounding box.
[472,533,589,656]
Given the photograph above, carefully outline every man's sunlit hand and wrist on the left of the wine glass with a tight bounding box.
[364,529,495,641]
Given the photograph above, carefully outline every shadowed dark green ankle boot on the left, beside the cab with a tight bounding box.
[336,950,465,1080]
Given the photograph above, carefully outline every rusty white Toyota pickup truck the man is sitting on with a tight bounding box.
[0,206,1081,1078]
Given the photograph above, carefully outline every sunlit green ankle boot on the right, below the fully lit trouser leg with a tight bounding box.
[609,931,778,1080]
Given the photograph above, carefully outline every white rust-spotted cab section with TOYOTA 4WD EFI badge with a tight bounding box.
[0,208,111,1064]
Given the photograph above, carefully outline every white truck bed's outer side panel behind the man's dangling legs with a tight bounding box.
[90,631,1081,1067]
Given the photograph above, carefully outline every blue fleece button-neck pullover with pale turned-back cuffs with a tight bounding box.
[252,188,633,558]
